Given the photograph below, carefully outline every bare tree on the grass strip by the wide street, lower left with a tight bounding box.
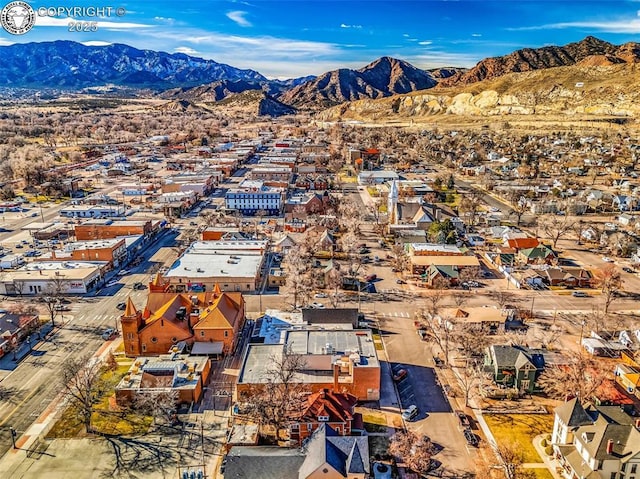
[62,355,106,432]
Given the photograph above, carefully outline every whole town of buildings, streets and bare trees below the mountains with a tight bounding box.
[0,99,640,479]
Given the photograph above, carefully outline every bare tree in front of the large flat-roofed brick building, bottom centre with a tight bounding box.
[246,345,310,437]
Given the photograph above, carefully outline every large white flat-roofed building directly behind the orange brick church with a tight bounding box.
[164,240,268,292]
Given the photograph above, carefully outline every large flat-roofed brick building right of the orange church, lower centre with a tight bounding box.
[235,326,380,401]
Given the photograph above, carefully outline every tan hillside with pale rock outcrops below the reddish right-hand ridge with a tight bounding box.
[318,63,640,121]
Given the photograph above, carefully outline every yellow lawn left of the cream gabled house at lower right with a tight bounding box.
[484,414,553,462]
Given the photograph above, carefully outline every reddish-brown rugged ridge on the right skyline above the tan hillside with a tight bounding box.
[440,36,640,86]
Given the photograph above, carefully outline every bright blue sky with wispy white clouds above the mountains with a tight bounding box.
[0,0,640,78]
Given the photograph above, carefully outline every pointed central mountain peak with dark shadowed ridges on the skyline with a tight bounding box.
[278,57,437,109]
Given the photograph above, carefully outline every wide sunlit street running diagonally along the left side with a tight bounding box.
[0,232,175,456]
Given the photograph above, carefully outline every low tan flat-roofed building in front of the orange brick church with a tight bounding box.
[116,353,211,406]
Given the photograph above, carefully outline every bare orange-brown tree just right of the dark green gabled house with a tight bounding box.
[538,350,610,401]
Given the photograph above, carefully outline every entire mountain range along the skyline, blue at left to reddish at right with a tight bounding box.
[0,36,640,114]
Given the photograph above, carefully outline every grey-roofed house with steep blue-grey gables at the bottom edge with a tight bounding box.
[224,424,370,479]
